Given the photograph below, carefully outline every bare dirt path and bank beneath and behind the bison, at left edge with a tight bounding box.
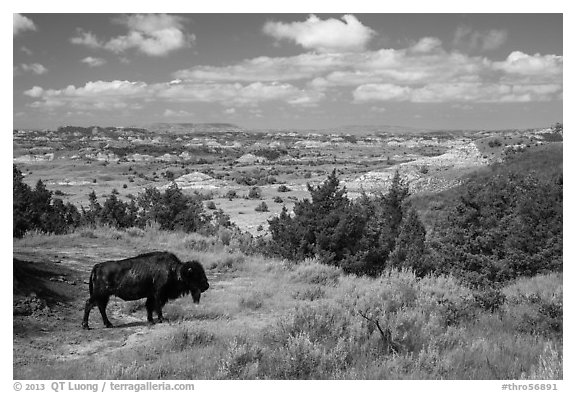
[13,246,222,379]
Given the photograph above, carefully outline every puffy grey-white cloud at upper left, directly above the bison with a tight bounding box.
[70,14,195,56]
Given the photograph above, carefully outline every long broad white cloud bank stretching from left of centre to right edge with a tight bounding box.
[174,41,562,102]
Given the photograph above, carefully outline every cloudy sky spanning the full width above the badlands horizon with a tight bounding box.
[13,13,563,129]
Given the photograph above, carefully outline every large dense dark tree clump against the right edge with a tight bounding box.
[432,172,562,286]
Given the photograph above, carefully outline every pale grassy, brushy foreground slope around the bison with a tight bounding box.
[13,228,563,379]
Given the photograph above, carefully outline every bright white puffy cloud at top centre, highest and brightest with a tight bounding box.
[263,15,375,52]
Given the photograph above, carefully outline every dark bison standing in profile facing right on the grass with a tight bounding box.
[82,251,209,329]
